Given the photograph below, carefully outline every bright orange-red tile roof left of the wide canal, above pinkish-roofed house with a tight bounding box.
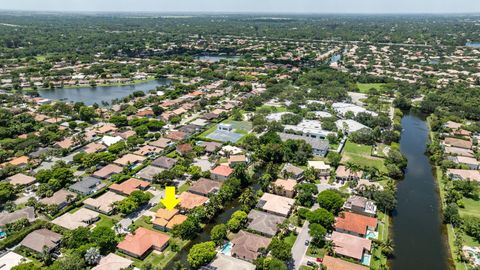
[335,212,377,235]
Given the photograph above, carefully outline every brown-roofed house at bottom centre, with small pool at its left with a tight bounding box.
[231,230,272,262]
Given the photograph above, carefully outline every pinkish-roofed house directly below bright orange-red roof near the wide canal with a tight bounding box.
[331,231,372,261]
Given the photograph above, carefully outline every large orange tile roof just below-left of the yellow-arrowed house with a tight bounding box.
[117,227,170,257]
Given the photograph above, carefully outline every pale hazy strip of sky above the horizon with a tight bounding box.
[0,0,480,14]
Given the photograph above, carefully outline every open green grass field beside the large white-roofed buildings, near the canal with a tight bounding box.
[342,141,387,172]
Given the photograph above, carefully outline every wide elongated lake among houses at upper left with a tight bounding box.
[38,79,171,105]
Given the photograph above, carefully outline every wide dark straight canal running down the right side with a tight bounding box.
[391,113,450,270]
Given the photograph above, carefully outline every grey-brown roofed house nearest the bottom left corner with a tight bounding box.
[20,229,62,254]
